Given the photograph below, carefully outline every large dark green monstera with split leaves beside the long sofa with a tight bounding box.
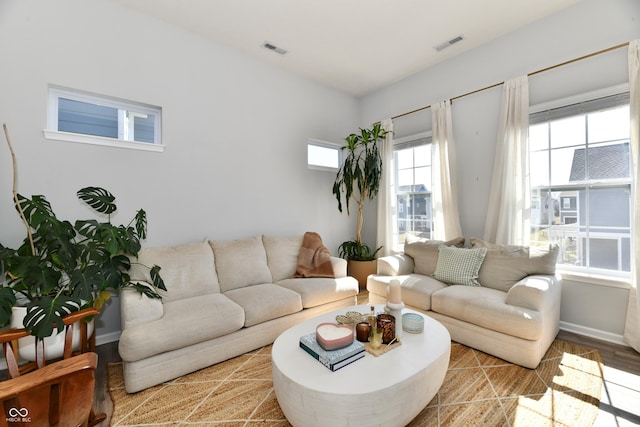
[0,126,166,346]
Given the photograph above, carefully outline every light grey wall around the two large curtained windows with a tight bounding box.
[361,0,640,340]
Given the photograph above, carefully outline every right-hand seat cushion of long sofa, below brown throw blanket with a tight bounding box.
[276,277,359,308]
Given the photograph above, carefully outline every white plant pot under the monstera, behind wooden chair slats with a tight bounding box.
[11,307,94,362]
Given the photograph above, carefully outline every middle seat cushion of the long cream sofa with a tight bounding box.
[224,283,302,327]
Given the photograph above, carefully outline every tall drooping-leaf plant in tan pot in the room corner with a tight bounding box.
[333,123,389,288]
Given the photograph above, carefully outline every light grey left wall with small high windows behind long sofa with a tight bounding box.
[0,0,358,337]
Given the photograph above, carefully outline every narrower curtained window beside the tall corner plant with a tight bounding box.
[393,133,433,249]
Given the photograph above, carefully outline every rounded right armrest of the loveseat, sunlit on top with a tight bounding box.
[506,274,562,311]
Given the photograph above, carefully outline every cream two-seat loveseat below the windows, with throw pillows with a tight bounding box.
[367,238,561,369]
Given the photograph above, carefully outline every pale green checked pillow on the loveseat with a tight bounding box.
[433,245,487,286]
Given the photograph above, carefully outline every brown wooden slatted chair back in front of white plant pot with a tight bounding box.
[0,308,106,426]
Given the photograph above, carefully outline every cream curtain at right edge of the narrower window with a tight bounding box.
[431,100,462,240]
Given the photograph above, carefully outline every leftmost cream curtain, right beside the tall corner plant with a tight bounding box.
[376,119,398,255]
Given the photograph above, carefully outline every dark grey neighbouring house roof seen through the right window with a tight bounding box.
[569,142,630,182]
